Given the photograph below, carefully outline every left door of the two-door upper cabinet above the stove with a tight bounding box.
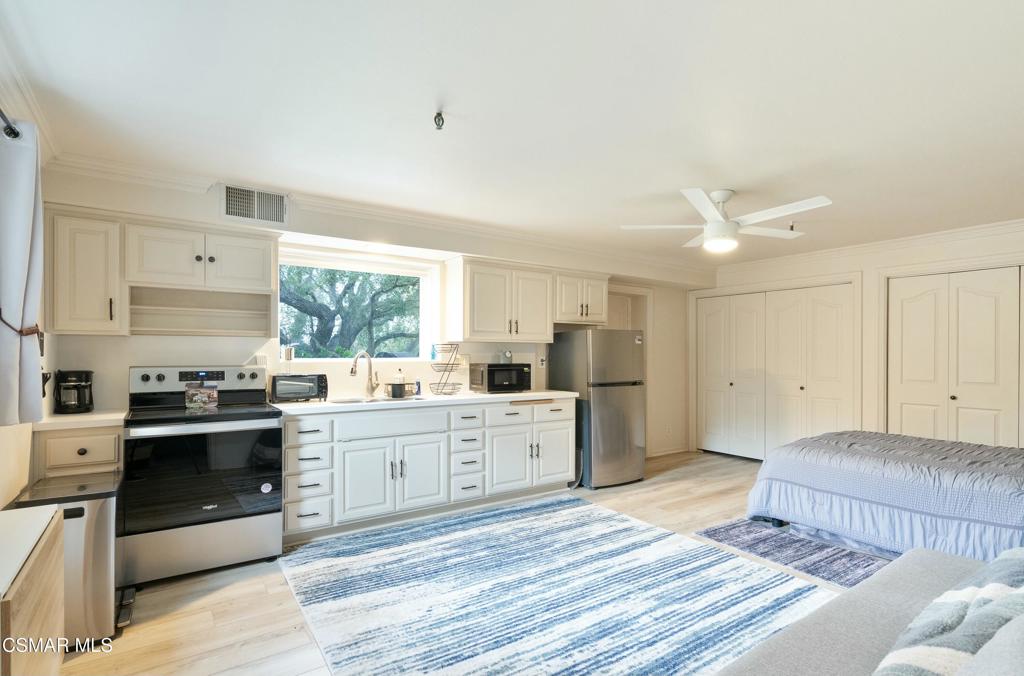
[125,224,207,287]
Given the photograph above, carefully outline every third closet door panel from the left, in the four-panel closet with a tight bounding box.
[765,289,806,453]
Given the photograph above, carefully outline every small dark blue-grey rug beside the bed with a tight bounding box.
[696,518,889,587]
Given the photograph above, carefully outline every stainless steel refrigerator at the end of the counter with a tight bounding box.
[548,329,647,489]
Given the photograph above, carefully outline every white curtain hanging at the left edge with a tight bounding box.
[0,116,43,425]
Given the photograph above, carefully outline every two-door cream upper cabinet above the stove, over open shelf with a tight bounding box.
[125,224,273,293]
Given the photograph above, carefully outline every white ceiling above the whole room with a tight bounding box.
[0,0,1024,265]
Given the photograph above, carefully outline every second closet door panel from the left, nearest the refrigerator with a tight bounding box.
[729,293,765,459]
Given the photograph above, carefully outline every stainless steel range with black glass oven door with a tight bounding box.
[117,366,283,586]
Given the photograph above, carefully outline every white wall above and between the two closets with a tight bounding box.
[704,220,1024,438]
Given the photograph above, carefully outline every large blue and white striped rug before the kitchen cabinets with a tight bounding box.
[280,497,835,674]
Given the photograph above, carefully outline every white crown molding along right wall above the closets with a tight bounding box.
[718,218,1024,274]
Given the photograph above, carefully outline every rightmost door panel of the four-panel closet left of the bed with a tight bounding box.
[804,284,853,436]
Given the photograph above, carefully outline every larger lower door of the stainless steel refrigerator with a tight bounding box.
[585,385,647,489]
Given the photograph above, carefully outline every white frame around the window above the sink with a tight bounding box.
[275,244,441,364]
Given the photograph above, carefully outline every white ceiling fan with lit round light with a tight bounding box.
[622,187,831,253]
